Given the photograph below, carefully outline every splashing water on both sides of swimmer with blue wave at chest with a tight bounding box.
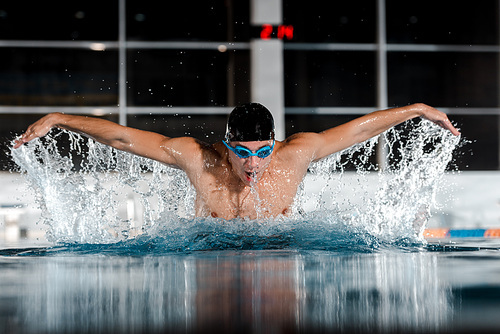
[11,121,460,250]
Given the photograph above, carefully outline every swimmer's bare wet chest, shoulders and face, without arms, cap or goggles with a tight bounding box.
[190,141,308,219]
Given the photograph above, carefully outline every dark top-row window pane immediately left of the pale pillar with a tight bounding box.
[127,0,250,41]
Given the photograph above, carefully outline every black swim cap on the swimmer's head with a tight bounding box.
[225,103,274,141]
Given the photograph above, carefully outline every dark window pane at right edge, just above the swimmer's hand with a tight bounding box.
[388,52,498,107]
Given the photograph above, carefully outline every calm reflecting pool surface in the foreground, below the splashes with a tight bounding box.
[0,239,500,333]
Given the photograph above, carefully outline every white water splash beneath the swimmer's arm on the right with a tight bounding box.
[301,120,461,243]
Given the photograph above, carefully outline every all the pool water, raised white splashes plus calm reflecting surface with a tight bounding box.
[0,123,500,333]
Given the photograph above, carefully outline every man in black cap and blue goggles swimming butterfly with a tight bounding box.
[14,103,459,219]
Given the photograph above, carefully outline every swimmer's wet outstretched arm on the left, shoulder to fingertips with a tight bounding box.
[14,113,199,168]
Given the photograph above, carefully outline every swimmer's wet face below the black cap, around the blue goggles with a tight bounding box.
[227,140,273,186]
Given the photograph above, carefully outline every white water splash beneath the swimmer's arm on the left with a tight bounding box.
[11,131,194,243]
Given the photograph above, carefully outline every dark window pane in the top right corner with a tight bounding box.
[386,0,499,45]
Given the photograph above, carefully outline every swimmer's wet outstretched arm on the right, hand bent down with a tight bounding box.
[311,103,460,160]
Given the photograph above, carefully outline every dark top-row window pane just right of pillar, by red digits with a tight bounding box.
[283,0,376,43]
